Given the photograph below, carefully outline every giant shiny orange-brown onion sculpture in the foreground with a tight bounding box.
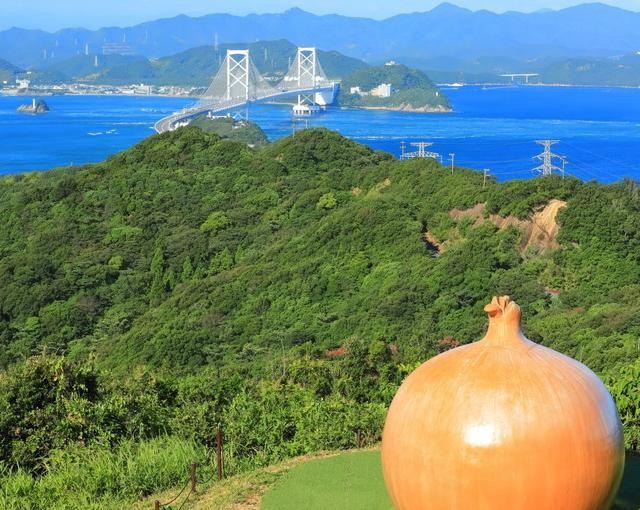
[382,297,624,510]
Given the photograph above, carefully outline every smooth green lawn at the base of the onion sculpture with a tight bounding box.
[260,451,640,510]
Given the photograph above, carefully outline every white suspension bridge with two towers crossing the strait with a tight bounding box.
[154,48,340,133]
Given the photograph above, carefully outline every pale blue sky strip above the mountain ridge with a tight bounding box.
[0,0,640,31]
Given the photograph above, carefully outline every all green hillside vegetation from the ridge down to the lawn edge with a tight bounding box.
[0,127,640,509]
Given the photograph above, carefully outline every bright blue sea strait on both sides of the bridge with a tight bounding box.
[0,86,640,182]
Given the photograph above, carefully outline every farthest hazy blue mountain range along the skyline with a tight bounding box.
[0,3,640,67]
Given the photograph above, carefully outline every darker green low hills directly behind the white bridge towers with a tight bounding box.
[38,40,368,87]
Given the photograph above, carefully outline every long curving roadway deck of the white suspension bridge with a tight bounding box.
[154,82,338,133]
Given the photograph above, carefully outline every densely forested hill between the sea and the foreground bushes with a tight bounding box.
[0,128,640,371]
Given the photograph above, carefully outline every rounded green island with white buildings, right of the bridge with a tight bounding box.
[338,61,452,113]
